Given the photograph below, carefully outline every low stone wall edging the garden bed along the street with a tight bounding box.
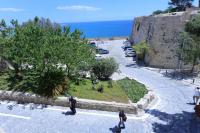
[0,90,156,115]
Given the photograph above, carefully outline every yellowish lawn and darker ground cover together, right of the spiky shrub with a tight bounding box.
[68,78,148,103]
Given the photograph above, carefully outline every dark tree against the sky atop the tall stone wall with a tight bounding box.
[169,0,194,11]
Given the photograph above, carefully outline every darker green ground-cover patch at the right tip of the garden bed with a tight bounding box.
[117,78,148,103]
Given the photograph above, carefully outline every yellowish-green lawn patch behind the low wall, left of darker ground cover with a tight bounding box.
[68,79,128,103]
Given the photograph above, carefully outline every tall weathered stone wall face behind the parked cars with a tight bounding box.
[131,11,198,69]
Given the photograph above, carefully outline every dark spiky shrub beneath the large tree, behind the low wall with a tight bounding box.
[36,70,69,97]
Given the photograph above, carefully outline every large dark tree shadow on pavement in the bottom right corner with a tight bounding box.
[146,110,200,133]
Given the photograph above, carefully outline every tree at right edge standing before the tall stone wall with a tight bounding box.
[179,16,200,72]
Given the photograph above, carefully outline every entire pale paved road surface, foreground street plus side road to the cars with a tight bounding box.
[0,40,200,133]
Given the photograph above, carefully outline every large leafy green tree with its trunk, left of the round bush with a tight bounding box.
[3,17,94,94]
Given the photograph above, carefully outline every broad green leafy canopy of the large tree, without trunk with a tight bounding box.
[4,17,93,76]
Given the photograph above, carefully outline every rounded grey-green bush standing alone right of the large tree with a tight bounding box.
[92,58,118,80]
